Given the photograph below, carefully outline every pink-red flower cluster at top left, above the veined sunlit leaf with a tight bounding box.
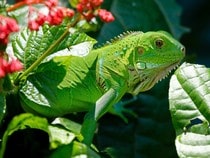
[28,0,74,30]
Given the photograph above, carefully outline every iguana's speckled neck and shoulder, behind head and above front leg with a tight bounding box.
[92,41,135,92]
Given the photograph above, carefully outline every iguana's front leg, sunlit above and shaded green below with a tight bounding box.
[81,88,117,146]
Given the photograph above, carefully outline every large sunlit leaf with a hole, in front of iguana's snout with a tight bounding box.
[169,63,210,158]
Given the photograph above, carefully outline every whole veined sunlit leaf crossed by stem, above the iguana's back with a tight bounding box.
[12,24,95,69]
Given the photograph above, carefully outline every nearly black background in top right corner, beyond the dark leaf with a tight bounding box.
[177,0,210,67]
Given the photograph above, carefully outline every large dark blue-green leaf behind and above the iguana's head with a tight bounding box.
[98,0,188,42]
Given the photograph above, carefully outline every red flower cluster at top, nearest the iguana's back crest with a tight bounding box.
[77,0,115,22]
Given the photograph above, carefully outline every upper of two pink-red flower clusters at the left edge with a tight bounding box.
[0,15,19,45]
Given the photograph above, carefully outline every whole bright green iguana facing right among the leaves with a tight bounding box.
[20,31,185,144]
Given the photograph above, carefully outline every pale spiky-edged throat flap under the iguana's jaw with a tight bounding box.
[131,61,180,95]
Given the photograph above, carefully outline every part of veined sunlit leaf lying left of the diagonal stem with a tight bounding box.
[12,25,66,69]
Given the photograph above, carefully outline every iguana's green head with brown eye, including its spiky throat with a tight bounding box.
[128,31,185,95]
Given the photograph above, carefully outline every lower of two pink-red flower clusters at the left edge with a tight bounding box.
[0,56,23,78]
